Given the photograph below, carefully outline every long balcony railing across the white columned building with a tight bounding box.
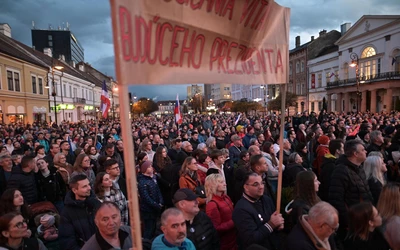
[326,71,400,89]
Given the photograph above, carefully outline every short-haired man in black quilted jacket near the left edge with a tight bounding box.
[7,156,39,205]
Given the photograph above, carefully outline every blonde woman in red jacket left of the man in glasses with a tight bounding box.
[205,174,237,250]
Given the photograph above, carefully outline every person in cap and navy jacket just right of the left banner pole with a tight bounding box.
[138,161,164,240]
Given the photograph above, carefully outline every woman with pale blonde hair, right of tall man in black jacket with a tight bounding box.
[364,155,387,204]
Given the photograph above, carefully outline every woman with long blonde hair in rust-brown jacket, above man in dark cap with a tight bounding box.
[179,156,206,206]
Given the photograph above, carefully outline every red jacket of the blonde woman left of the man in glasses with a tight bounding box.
[206,194,237,250]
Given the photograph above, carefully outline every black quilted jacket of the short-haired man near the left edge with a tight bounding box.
[7,166,39,205]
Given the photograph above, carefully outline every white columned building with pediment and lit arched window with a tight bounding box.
[326,15,400,113]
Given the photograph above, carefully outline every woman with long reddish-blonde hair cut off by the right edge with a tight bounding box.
[377,183,400,250]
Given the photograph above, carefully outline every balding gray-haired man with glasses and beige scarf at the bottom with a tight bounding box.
[286,201,339,250]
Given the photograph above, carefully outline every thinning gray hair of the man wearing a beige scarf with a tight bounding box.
[308,201,338,225]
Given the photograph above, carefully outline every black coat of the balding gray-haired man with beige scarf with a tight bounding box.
[286,220,336,250]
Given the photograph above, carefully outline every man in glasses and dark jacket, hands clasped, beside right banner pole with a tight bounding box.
[232,173,284,249]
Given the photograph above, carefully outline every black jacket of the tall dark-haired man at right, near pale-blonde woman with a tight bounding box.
[329,155,374,228]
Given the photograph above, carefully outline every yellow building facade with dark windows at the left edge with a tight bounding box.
[0,50,49,124]
